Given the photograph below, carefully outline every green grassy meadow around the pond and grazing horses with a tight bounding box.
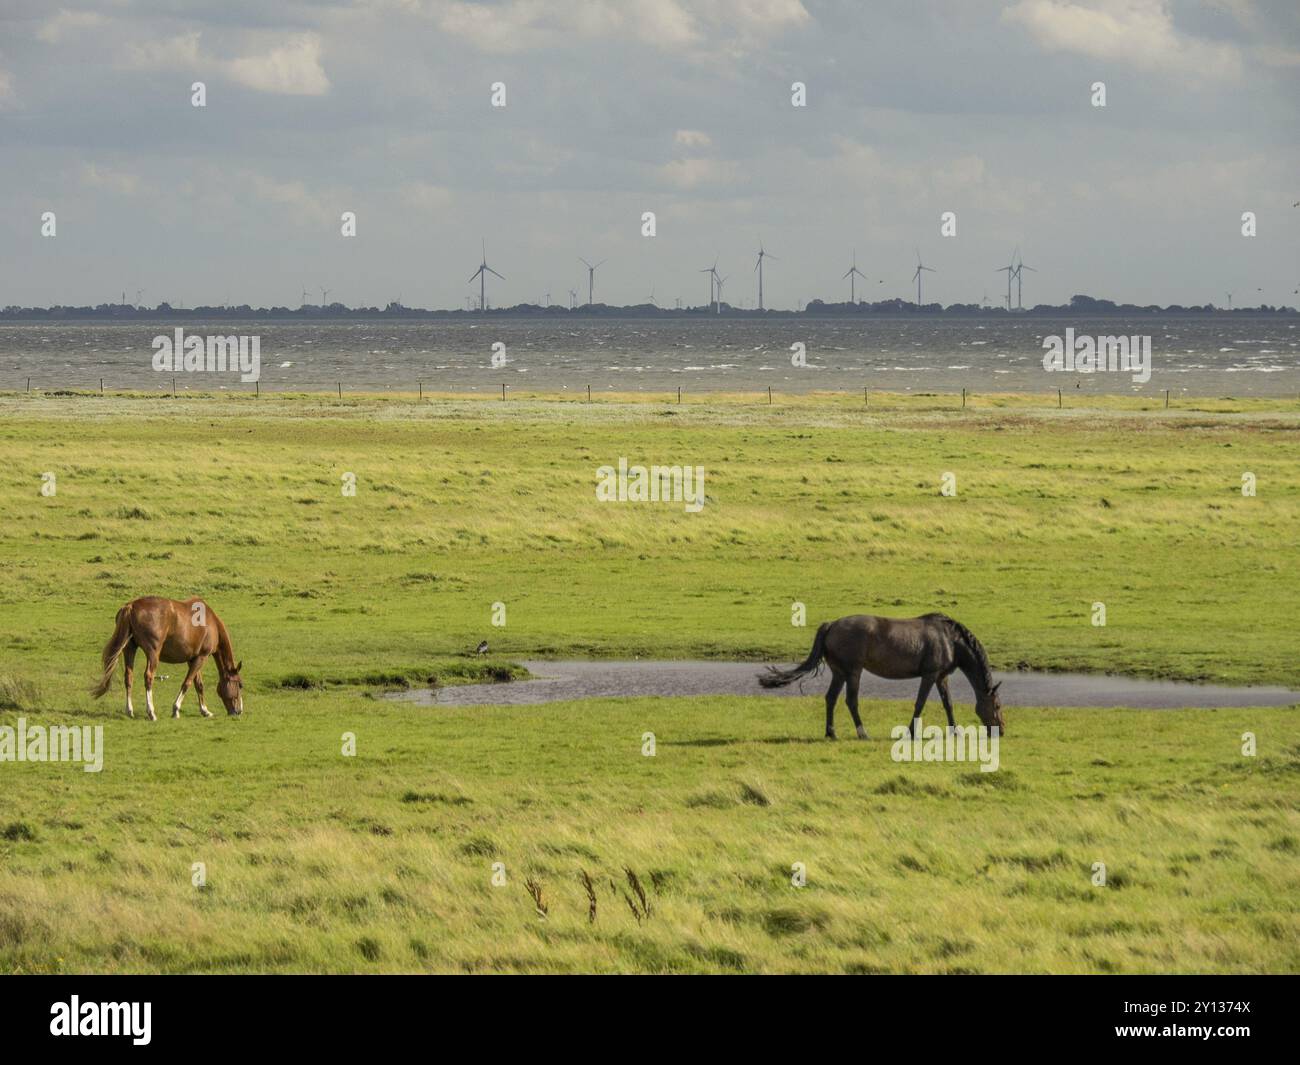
[0,394,1300,973]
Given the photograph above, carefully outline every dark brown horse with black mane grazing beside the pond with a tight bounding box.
[758,614,1006,740]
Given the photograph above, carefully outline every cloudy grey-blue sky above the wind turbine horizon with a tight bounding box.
[0,0,1300,307]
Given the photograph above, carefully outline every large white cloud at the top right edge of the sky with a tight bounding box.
[1002,0,1242,78]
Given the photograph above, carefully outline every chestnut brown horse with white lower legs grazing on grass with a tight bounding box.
[91,596,243,722]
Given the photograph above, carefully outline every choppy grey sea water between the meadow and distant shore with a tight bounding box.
[0,321,1300,397]
